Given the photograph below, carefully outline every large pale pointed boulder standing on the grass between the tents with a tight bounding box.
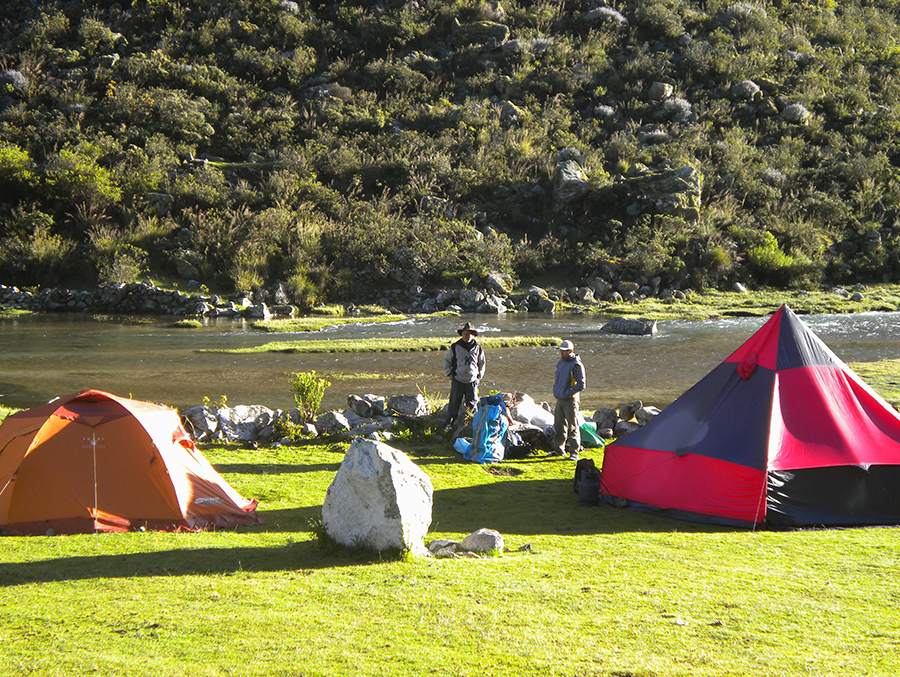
[322,438,434,554]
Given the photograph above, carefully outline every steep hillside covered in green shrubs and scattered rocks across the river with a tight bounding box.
[0,0,900,305]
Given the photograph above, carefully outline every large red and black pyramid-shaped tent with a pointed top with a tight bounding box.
[600,306,900,527]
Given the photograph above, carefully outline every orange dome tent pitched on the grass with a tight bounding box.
[0,390,260,534]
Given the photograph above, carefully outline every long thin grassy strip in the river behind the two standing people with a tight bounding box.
[207,336,562,353]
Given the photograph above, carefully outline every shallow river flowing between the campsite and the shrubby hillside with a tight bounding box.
[0,313,900,411]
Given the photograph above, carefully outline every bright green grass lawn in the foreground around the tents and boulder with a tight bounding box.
[0,444,900,677]
